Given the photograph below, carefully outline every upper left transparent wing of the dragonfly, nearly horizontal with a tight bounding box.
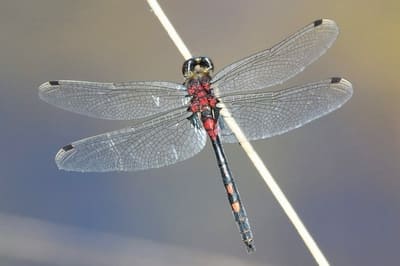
[39,80,190,120]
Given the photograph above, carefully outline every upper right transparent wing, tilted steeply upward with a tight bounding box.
[212,19,339,95]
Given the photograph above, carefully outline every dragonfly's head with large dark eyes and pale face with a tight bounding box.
[182,56,214,79]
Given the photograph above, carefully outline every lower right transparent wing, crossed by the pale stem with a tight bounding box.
[219,78,353,143]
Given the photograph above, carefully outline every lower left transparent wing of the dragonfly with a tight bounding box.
[55,110,206,172]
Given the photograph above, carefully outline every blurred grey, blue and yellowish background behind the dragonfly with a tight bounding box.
[0,0,400,266]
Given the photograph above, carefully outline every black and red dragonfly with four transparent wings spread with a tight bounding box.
[39,19,353,253]
